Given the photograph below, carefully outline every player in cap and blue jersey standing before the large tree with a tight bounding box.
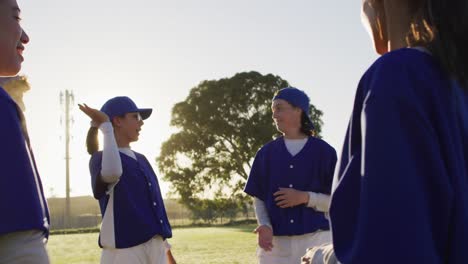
[244,87,336,263]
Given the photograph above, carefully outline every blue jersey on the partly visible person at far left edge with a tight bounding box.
[0,87,50,237]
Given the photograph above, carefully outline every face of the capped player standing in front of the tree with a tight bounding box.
[271,99,302,135]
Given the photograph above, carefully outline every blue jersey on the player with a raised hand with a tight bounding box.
[89,152,172,248]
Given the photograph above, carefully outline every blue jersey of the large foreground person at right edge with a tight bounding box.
[330,48,468,264]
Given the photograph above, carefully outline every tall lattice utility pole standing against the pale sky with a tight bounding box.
[60,90,75,228]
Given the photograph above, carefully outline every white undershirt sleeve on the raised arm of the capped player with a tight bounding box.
[99,122,122,183]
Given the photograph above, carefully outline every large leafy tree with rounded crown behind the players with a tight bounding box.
[158,72,322,205]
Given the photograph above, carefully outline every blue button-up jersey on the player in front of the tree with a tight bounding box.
[244,137,336,236]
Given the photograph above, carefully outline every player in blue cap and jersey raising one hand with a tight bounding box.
[80,96,172,264]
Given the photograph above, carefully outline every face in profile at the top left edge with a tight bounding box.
[0,0,29,76]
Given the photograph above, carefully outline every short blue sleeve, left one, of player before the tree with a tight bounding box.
[244,149,267,201]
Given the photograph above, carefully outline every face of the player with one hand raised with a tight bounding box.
[113,112,144,147]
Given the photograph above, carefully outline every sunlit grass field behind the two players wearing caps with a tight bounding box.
[47,225,256,264]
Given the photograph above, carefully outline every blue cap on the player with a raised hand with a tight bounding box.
[101,96,153,120]
